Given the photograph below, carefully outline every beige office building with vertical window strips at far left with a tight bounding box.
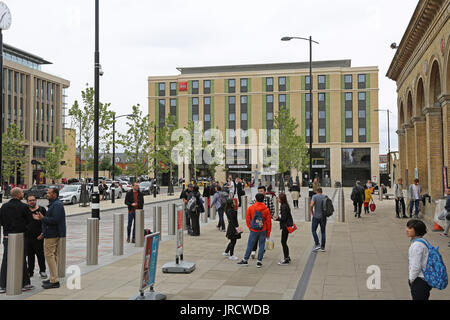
[2,44,70,187]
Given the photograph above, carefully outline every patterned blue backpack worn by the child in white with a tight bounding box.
[416,239,448,290]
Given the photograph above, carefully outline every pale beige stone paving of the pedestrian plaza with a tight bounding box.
[1,189,450,300]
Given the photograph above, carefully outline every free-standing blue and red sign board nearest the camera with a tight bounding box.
[132,232,167,300]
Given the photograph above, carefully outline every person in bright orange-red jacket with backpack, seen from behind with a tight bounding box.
[238,193,272,268]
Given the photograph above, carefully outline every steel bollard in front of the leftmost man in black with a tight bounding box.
[6,233,25,296]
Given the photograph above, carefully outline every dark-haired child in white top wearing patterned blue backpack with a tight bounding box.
[406,219,448,300]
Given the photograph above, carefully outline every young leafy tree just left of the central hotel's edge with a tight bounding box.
[117,104,153,179]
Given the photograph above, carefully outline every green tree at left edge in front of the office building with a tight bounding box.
[2,123,28,184]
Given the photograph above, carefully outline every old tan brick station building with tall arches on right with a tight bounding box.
[387,0,450,202]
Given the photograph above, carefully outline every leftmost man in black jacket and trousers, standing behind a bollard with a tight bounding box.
[0,188,34,293]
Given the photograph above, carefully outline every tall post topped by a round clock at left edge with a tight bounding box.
[0,2,11,203]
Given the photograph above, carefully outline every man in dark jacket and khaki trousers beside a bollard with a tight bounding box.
[33,188,66,289]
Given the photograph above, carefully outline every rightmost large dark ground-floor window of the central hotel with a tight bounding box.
[342,148,372,187]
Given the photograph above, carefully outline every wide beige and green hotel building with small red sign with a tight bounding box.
[148,60,379,186]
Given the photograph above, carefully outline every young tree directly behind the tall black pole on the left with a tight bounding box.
[69,84,113,177]
